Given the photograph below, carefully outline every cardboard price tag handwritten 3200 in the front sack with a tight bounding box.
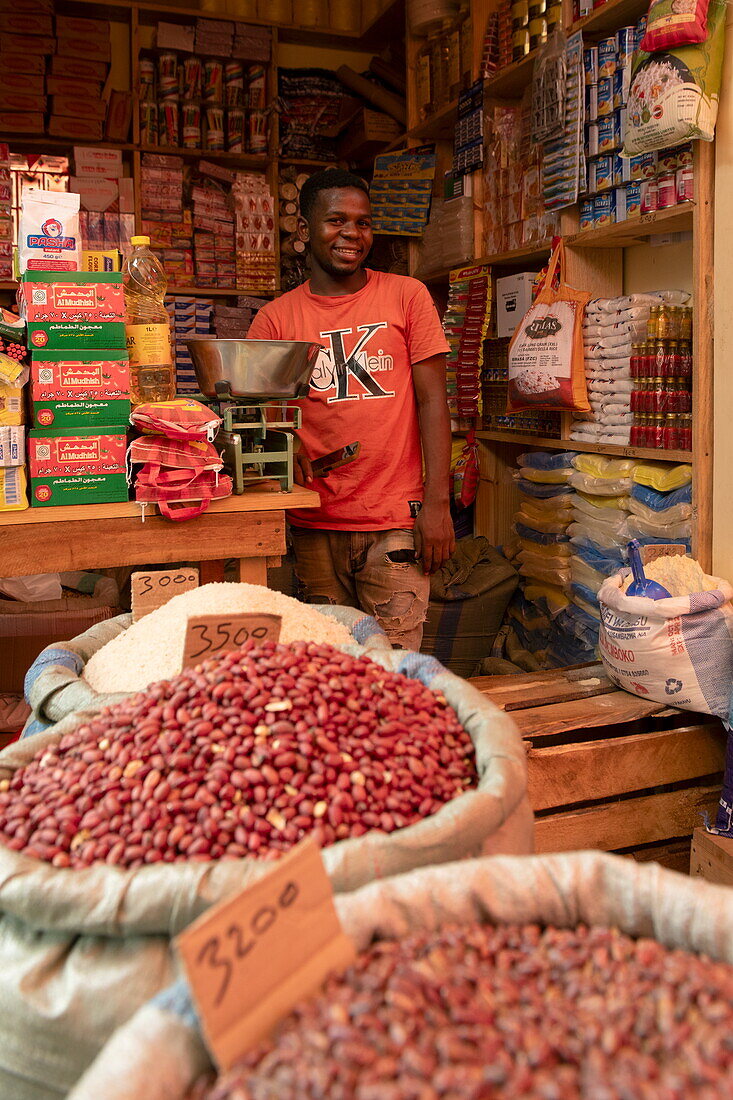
[175,838,357,1069]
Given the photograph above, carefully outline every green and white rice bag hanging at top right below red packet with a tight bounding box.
[623,0,725,156]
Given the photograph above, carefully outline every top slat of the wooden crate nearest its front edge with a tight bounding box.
[512,690,679,741]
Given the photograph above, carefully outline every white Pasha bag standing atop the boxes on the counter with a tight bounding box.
[18,190,81,274]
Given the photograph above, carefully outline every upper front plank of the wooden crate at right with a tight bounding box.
[527,726,725,811]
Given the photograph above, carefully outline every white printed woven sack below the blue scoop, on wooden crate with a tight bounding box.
[598,573,733,721]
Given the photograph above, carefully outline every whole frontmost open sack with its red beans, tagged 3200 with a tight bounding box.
[69,851,733,1100]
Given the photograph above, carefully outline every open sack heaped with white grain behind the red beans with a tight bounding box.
[24,584,391,736]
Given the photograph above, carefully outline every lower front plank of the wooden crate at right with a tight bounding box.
[535,784,720,853]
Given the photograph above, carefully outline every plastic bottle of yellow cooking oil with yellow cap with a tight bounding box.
[122,237,176,405]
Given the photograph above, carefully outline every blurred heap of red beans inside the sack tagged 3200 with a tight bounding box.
[195,924,733,1100]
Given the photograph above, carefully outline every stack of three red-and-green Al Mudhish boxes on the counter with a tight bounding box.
[20,272,130,507]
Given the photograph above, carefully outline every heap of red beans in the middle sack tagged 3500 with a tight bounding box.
[0,642,477,867]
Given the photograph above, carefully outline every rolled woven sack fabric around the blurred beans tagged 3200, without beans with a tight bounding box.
[68,851,733,1100]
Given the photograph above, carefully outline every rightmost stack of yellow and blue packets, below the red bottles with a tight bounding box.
[627,462,692,553]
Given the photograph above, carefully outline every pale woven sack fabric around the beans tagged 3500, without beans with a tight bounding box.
[0,646,533,1100]
